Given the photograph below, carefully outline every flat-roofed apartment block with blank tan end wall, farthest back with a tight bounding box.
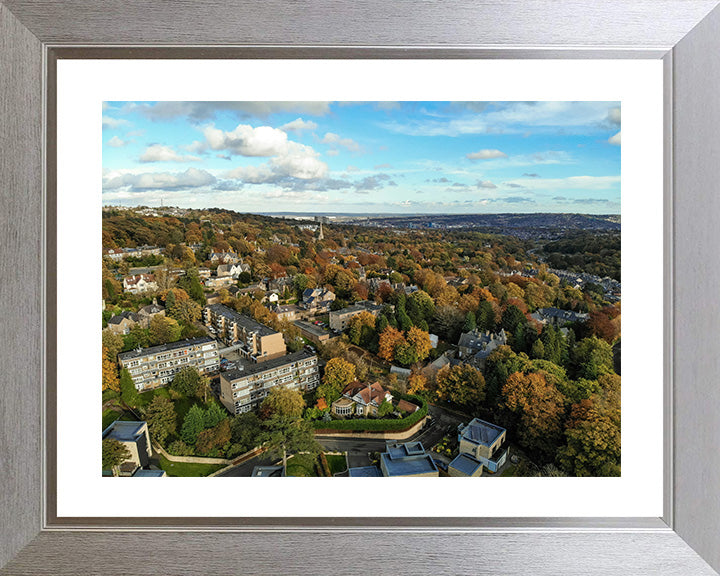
[203,304,287,362]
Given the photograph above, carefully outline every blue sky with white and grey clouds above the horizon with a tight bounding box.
[102,102,620,214]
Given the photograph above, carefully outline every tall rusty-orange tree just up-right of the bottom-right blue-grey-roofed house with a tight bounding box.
[502,372,564,457]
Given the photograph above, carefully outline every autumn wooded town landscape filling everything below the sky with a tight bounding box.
[102,206,621,477]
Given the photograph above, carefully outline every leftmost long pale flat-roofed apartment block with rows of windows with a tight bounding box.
[118,336,220,392]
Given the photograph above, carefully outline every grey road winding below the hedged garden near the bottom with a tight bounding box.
[218,406,464,477]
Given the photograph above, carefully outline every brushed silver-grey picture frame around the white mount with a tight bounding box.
[0,0,720,575]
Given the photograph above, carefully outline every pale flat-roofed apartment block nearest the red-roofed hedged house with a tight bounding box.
[220,350,320,414]
